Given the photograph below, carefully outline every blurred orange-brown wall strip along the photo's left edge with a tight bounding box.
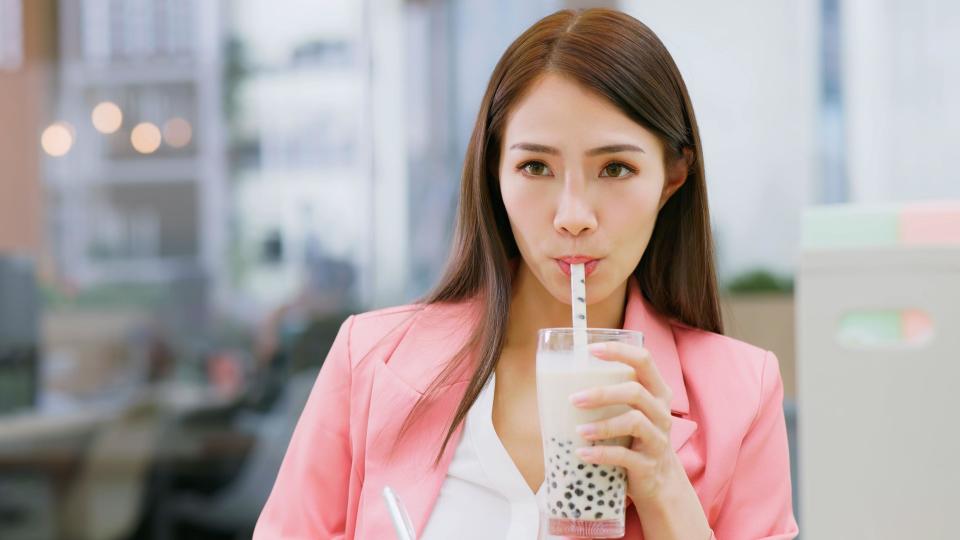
[0,0,56,257]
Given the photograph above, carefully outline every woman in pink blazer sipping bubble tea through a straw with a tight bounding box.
[255,9,797,540]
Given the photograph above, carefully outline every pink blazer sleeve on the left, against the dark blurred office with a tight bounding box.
[253,316,353,540]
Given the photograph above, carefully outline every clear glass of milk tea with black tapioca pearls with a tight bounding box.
[537,328,643,538]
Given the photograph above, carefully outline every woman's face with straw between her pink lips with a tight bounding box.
[500,74,687,304]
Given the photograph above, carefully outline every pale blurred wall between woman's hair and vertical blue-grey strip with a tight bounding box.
[620,0,821,278]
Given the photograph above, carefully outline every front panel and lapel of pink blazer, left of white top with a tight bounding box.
[356,303,475,538]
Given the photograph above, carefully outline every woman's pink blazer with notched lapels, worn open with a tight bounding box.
[254,280,797,540]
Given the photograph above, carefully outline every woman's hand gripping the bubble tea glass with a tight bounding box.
[570,342,686,508]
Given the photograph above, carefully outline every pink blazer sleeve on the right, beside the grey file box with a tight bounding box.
[712,351,799,540]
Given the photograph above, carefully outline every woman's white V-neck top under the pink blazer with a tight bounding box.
[420,374,563,540]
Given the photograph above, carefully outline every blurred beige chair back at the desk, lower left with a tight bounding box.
[61,401,163,540]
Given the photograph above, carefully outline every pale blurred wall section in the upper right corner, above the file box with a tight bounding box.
[840,0,960,203]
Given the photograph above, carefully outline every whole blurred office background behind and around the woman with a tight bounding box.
[0,0,960,539]
